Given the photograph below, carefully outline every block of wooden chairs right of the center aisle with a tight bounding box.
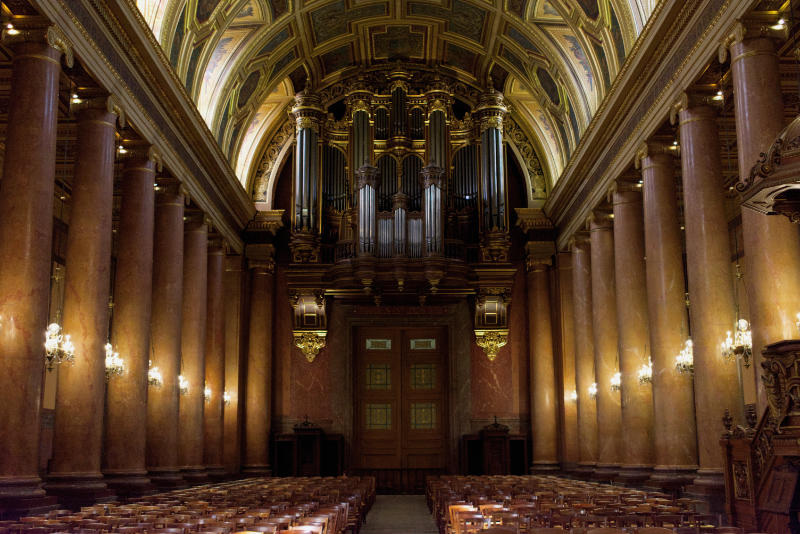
[426,475,760,534]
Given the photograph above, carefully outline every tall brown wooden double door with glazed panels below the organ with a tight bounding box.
[353,327,448,482]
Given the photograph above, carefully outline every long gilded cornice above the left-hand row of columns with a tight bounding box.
[33,0,254,250]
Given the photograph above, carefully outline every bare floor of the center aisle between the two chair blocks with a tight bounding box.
[361,495,439,534]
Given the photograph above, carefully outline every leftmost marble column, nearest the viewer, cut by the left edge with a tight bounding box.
[0,25,61,514]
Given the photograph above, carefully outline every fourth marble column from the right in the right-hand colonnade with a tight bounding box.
[613,185,653,484]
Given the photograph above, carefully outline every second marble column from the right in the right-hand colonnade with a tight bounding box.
[679,95,748,492]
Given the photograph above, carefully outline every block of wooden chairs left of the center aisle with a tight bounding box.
[0,477,375,534]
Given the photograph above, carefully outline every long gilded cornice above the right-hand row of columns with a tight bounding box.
[545,0,751,252]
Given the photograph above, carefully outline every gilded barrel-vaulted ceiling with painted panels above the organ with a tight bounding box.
[136,0,656,195]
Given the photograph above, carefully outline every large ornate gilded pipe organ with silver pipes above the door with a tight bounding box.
[290,67,514,360]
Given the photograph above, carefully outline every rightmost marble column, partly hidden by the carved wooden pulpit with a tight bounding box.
[730,27,800,408]
